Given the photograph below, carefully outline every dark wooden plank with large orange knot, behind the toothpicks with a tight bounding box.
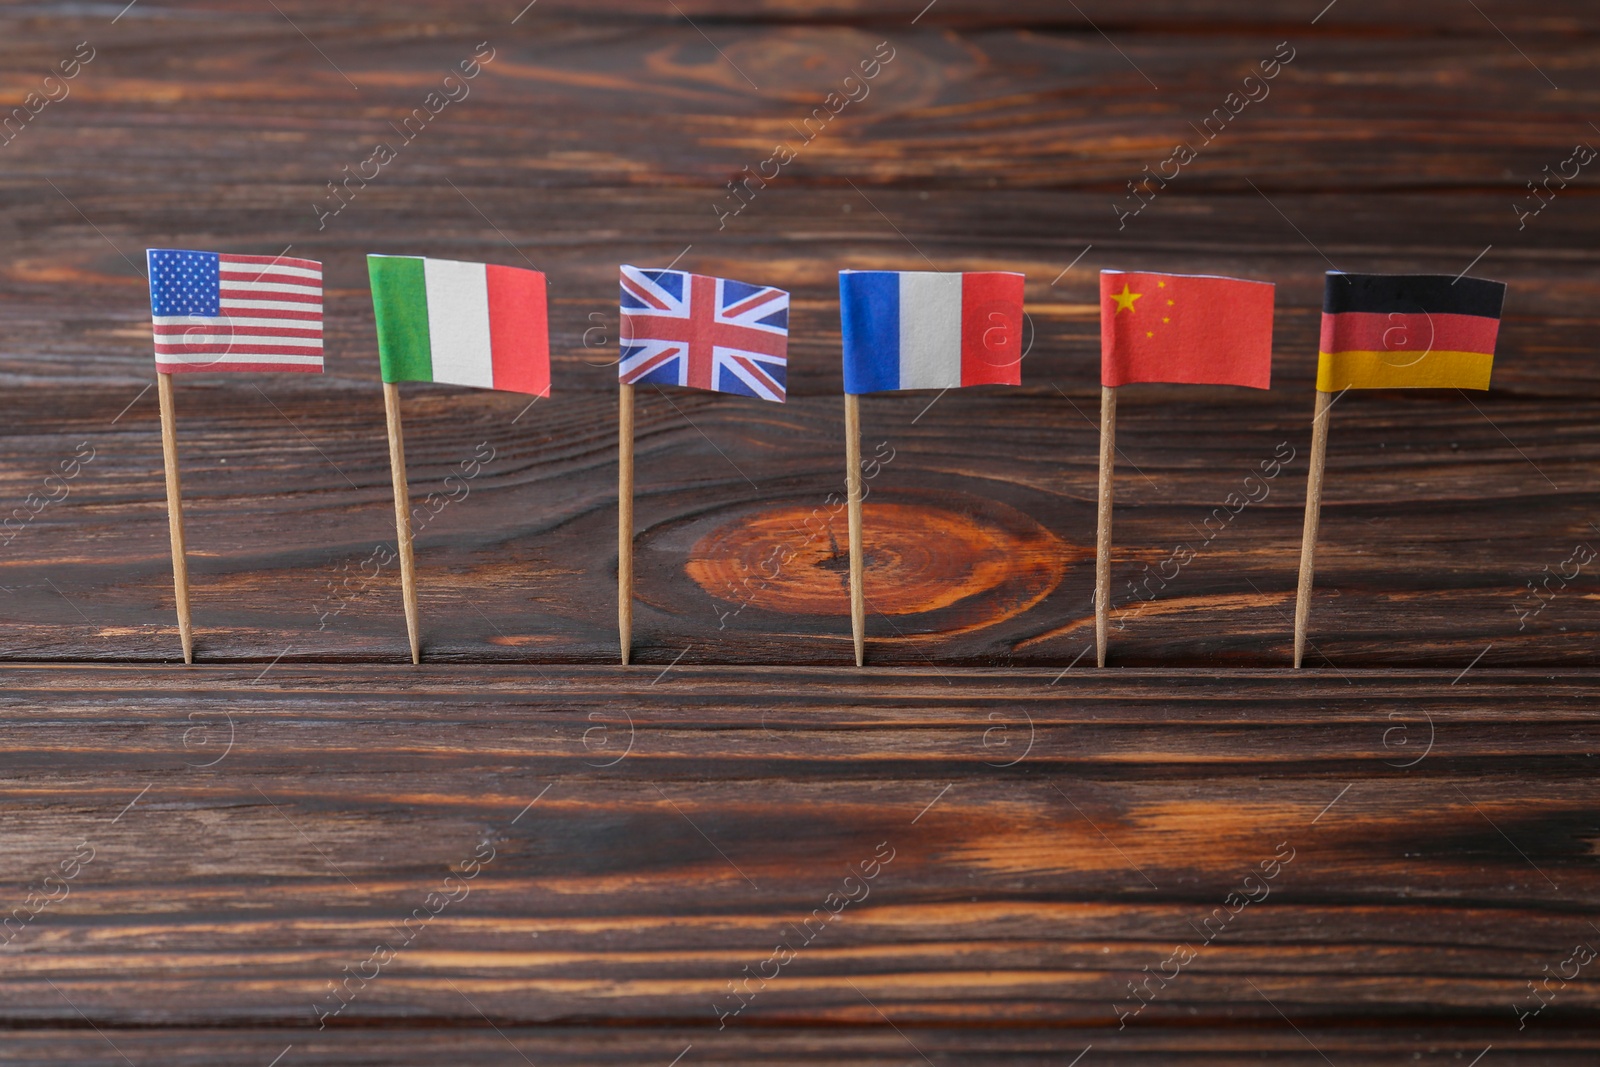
[0,381,1600,670]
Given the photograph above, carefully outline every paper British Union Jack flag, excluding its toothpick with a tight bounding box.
[618,267,789,403]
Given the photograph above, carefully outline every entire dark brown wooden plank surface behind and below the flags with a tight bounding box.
[0,0,1600,1067]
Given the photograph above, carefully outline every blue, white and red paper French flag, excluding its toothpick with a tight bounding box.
[838,270,1022,394]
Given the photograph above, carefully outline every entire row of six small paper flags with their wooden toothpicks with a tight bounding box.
[149,248,1506,667]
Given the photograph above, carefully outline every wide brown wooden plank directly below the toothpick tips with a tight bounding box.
[0,664,1600,1033]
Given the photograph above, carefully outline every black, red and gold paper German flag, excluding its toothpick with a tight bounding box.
[1317,270,1506,392]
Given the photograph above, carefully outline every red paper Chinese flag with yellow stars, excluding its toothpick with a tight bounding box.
[1101,270,1274,389]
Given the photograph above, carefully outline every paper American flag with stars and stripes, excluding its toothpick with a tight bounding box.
[147,248,322,374]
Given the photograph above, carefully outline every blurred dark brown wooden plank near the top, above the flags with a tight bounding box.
[5,16,1600,204]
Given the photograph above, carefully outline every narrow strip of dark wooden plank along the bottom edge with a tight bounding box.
[9,1023,1594,1067]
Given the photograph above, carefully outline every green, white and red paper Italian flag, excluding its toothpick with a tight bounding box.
[366,256,550,397]
